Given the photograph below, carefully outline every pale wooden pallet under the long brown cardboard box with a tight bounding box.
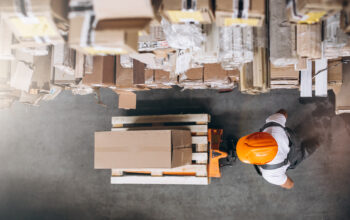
[111,114,210,185]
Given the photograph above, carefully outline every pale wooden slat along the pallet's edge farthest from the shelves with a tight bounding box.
[111,176,209,185]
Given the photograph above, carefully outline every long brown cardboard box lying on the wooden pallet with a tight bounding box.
[94,130,192,169]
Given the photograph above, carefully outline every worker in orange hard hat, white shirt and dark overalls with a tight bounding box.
[236,109,305,189]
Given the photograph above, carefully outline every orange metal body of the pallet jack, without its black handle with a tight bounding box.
[208,128,228,178]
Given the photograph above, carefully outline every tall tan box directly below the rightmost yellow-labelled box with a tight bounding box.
[297,24,322,59]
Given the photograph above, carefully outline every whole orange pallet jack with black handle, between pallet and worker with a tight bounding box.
[208,128,236,178]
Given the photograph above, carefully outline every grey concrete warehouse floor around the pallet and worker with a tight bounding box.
[0,89,350,220]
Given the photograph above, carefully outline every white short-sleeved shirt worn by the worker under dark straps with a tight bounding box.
[260,113,289,185]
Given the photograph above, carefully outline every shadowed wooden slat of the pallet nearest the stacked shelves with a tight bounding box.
[112,114,210,125]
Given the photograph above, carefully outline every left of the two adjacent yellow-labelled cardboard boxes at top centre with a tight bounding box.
[161,0,214,24]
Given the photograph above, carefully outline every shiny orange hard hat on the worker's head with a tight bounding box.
[236,132,278,165]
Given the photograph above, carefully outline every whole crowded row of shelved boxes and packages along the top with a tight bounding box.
[0,0,350,115]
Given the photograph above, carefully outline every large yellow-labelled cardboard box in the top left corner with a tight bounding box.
[0,0,68,47]
